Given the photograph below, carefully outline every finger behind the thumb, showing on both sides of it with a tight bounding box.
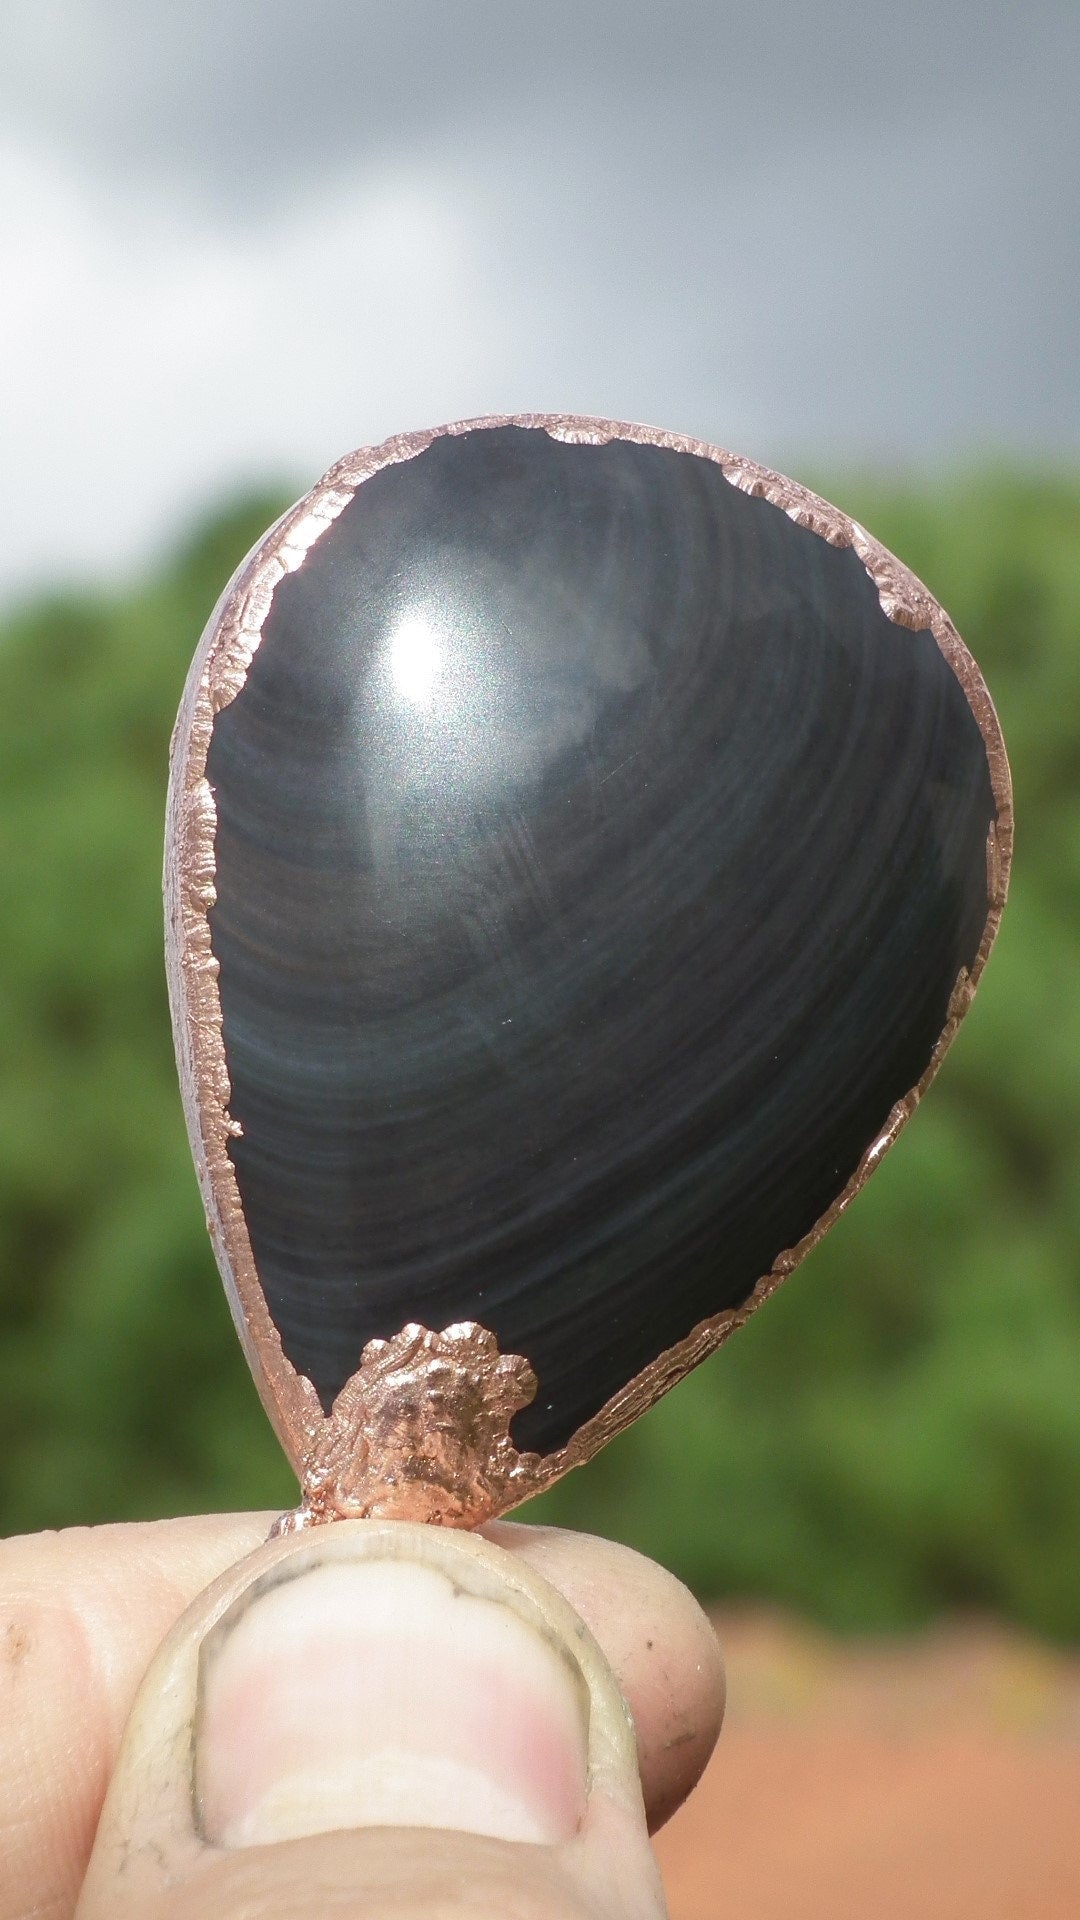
[0,1513,723,1920]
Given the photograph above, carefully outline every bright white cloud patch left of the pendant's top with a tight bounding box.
[0,152,500,591]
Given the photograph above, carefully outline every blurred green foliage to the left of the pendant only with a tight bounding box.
[0,499,294,1530]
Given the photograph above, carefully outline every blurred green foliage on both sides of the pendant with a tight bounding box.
[0,472,1080,1636]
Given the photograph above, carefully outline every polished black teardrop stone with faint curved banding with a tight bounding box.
[208,426,994,1452]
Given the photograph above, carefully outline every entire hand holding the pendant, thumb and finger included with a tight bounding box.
[0,1515,723,1920]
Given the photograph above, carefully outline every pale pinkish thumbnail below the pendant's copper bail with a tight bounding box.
[194,1528,590,1847]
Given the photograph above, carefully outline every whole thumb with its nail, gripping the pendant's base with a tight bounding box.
[77,1521,665,1920]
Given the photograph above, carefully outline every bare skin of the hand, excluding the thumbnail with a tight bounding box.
[0,1513,724,1920]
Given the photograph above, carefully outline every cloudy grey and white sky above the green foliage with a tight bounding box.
[0,0,1080,603]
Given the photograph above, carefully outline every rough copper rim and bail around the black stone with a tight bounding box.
[165,413,1013,1526]
